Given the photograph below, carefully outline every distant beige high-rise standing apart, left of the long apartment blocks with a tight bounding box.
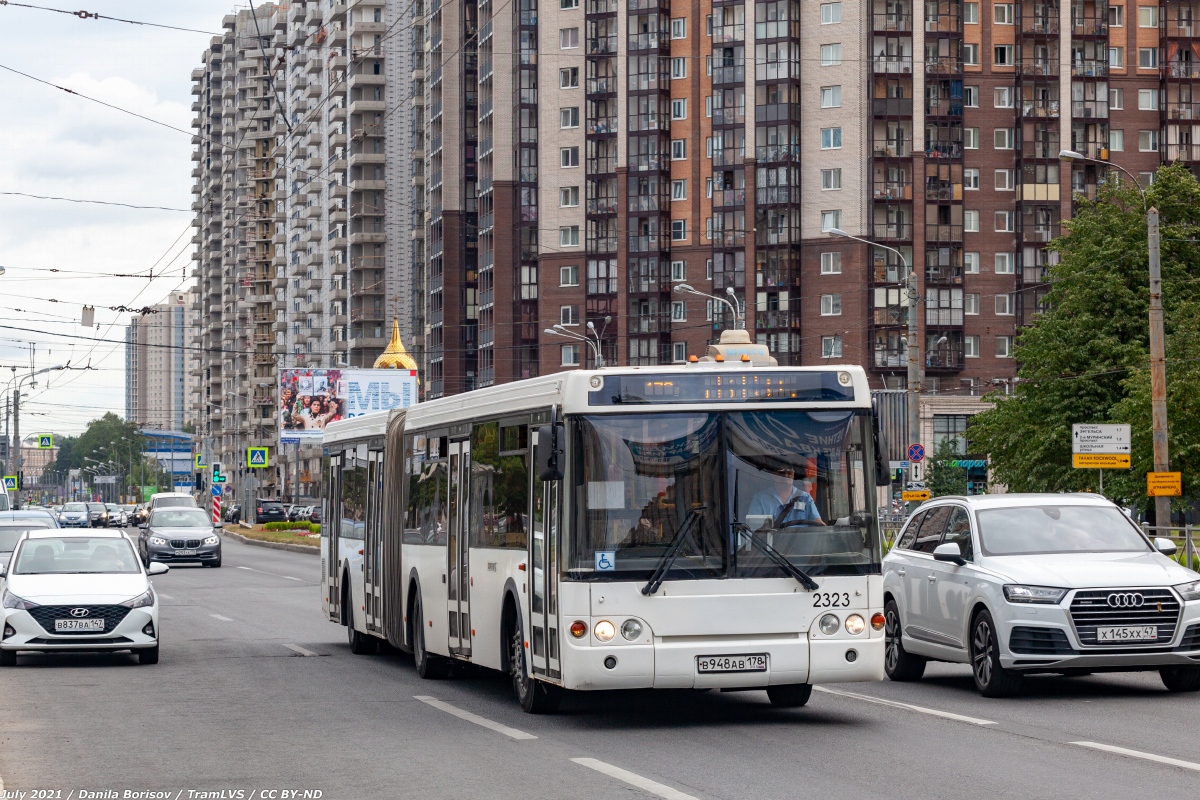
[125,291,199,431]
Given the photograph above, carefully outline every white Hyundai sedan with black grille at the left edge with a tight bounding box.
[0,528,169,667]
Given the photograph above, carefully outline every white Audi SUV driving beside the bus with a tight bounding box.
[883,494,1200,697]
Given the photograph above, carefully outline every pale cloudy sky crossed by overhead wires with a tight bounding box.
[0,0,248,434]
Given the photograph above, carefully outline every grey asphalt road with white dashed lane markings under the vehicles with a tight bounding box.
[0,541,1200,800]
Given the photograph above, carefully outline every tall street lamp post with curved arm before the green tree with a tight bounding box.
[1058,150,1171,533]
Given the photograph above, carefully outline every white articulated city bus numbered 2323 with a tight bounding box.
[322,352,887,712]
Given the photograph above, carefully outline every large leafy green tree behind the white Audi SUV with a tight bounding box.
[968,166,1200,507]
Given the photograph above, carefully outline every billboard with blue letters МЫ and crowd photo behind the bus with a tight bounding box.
[280,369,416,444]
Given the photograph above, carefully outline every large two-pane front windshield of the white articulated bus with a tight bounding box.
[565,410,881,581]
